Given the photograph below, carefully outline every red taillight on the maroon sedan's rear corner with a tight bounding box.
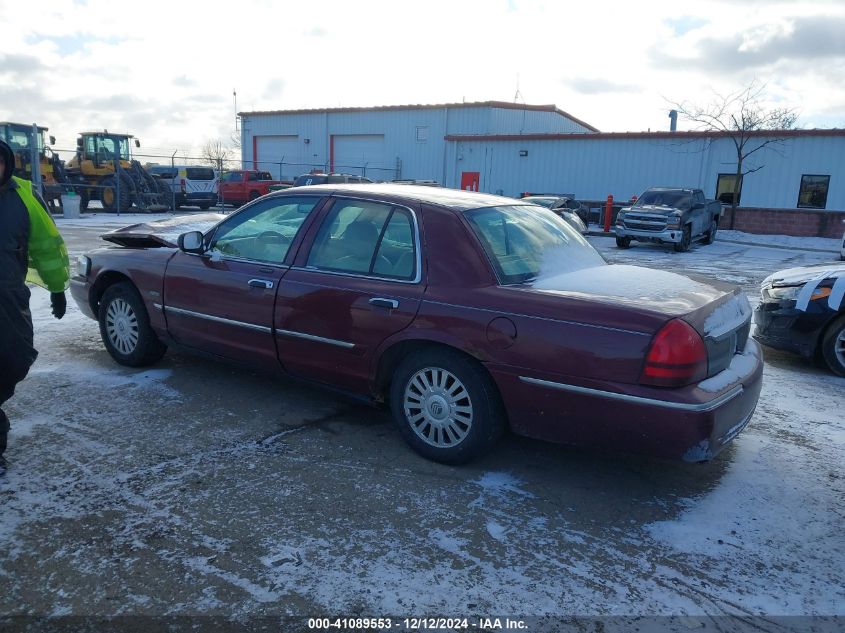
[640,319,707,387]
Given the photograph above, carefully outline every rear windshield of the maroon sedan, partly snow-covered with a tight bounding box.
[466,205,605,285]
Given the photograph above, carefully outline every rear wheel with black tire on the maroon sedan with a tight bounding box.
[390,349,505,464]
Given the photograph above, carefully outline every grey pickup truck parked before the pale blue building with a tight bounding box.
[616,187,722,253]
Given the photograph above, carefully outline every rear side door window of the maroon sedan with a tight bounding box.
[307,199,417,280]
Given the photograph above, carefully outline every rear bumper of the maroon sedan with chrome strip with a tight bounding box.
[490,340,763,462]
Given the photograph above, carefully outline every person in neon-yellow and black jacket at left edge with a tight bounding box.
[0,141,70,456]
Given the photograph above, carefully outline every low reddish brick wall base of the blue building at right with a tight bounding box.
[719,207,845,238]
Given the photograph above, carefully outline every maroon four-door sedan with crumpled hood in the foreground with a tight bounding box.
[71,184,762,463]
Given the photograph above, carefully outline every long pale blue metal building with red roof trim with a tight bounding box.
[240,101,845,232]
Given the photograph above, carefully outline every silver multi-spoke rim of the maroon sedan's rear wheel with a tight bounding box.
[403,367,473,448]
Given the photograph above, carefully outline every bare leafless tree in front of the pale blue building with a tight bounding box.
[673,80,798,228]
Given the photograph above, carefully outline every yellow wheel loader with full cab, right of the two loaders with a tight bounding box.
[65,130,173,211]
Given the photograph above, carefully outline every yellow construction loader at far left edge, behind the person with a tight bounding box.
[0,121,67,210]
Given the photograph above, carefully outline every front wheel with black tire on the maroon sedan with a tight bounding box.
[97,281,167,367]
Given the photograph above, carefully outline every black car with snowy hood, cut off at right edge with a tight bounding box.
[754,263,845,376]
